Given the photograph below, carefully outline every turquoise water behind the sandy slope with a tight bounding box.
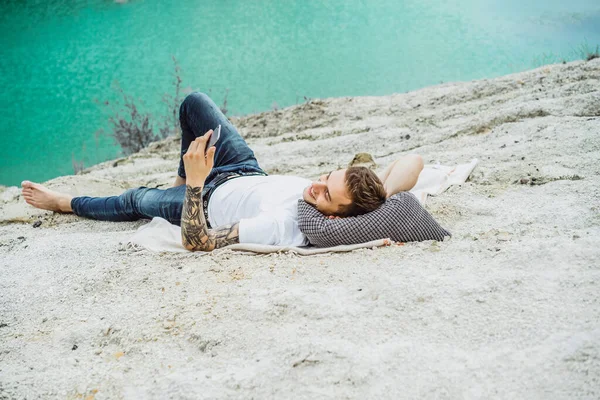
[0,0,600,185]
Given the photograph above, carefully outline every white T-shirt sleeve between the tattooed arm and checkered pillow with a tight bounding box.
[240,212,308,246]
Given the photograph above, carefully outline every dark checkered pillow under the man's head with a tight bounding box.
[298,192,450,247]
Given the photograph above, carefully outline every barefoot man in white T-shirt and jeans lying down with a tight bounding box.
[21,92,423,251]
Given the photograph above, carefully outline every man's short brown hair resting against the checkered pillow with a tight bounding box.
[337,167,387,217]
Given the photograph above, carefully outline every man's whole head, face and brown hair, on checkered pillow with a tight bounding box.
[303,167,386,217]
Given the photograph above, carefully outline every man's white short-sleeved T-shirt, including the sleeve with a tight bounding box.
[208,175,311,246]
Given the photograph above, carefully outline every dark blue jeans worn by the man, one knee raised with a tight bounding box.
[71,92,266,225]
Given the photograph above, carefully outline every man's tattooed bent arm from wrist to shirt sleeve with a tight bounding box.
[181,185,240,251]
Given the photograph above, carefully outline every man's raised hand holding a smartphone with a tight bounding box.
[183,125,221,187]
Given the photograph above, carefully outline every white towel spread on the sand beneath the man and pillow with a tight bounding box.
[127,159,478,255]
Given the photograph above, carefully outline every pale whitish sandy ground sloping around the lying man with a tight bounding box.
[0,60,600,399]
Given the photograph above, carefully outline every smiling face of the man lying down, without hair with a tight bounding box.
[302,169,352,215]
